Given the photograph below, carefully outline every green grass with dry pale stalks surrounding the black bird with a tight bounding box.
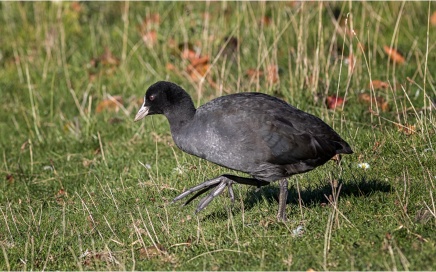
[0,2,436,270]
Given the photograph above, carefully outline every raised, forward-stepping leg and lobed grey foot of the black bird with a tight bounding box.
[172,175,269,212]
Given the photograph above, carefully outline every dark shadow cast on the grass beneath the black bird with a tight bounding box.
[199,178,392,220]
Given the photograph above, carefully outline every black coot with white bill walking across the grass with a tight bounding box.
[134,81,353,221]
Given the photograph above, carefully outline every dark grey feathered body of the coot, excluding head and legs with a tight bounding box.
[173,93,352,181]
